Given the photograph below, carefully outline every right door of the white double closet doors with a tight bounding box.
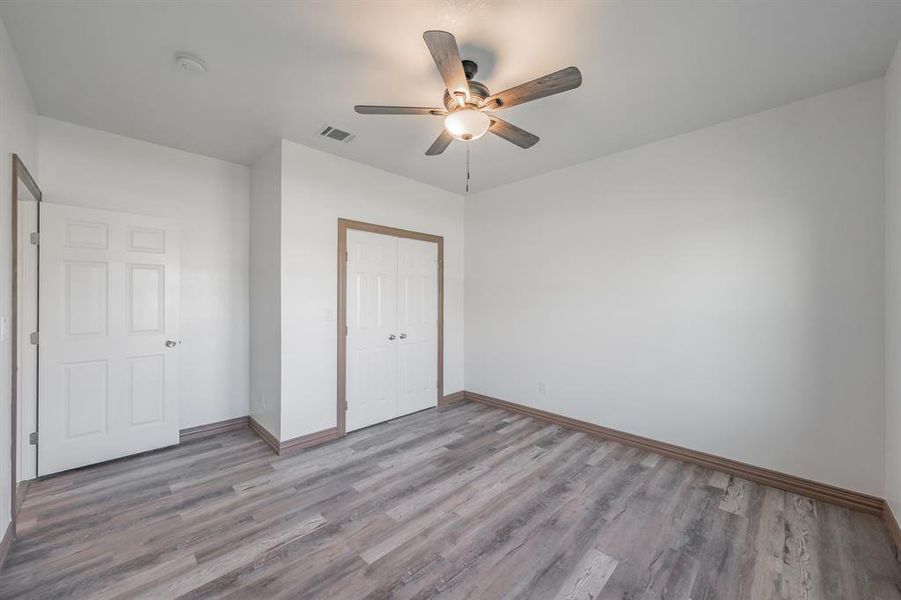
[397,238,438,415]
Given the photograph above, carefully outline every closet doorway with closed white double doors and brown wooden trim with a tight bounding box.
[338,219,444,436]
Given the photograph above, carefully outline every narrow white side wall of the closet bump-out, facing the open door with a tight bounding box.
[250,141,282,437]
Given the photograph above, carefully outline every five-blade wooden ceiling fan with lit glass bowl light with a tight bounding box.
[354,31,582,156]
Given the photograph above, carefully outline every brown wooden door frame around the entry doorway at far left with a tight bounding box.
[9,154,42,536]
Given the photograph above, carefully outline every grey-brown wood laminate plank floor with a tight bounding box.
[0,403,901,600]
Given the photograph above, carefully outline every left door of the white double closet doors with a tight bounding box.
[345,229,398,431]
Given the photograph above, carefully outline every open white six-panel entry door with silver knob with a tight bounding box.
[38,202,179,475]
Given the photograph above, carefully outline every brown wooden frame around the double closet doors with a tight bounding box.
[335,219,444,438]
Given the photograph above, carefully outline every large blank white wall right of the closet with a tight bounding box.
[465,80,884,495]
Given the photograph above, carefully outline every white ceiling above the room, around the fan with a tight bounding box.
[0,0,901,192]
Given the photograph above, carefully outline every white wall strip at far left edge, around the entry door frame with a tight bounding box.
[0,16,38,536]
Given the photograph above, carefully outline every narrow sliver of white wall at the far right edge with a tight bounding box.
[885,45,901,510]
